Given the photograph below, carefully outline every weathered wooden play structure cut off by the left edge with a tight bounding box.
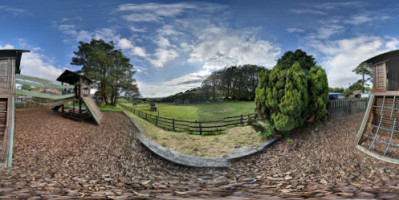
[0,49,29,167]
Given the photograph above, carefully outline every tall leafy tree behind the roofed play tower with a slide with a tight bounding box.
[71,39,139,105]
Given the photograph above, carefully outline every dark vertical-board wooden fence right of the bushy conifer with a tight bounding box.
[327,98,369,119]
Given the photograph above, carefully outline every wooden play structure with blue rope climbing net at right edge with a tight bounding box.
[356,50,399,164]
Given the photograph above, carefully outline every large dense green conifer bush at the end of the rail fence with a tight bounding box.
[255,50,328,131]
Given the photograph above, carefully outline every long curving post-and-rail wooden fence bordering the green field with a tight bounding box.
[118,104,254,135]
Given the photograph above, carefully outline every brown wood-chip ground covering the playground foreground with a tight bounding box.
[0,108,399,199]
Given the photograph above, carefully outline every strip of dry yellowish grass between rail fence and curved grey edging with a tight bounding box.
[121,106,264,158]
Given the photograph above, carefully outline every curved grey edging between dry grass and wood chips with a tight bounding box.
[122,111,277,168]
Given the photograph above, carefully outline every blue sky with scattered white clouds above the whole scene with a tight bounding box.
[0,0,399,97]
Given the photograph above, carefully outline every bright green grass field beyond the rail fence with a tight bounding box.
[123,101,255,121]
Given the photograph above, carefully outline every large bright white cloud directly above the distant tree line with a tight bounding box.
[188,27,281,70]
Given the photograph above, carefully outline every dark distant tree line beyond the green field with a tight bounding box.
[163,65,268,103]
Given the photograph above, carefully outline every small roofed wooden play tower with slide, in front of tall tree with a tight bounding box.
[57,70,102,124]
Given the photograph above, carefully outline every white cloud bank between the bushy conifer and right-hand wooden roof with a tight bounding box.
[313,36,399,87]
